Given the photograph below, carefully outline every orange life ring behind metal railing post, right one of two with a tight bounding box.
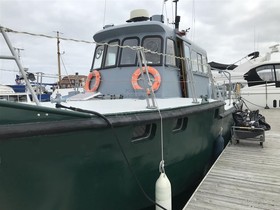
[131,66,161,91]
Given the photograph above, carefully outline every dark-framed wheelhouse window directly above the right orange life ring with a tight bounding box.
[142,37,162,65]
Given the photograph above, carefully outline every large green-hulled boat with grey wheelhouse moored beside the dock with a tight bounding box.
[0,2,235,210]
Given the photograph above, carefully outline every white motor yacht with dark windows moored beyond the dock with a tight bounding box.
[212,44,280,110]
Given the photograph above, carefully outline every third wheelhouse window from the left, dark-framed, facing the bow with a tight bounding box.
[120,38,139,66]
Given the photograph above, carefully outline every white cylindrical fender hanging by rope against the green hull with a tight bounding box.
[156,173,172,210]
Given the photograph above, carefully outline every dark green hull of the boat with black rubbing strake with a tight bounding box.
[0,102,232,210]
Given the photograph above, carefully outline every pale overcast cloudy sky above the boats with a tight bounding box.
[0,0,280,84]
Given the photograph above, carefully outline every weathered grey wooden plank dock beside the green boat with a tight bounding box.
[183,109,280,210]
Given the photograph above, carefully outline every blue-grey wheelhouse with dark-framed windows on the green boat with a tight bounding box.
[89,17,212,98]
